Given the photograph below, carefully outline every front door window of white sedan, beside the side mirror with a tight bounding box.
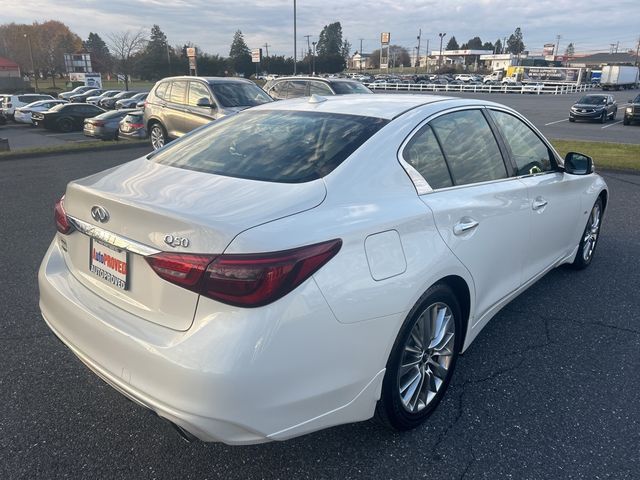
[491,110,554,175]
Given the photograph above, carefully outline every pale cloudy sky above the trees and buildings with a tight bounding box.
[5,0,640,57]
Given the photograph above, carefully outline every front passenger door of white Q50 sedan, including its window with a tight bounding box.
[490,108,585,281]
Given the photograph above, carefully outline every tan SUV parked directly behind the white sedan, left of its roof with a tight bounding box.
[144,77,273,149]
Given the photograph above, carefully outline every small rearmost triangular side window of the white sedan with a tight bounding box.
[402,125,453,189]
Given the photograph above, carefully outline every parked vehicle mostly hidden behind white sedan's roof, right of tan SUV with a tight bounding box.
[264,77,377,100]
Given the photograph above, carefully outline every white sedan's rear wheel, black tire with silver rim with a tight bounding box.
[374,284,462,431]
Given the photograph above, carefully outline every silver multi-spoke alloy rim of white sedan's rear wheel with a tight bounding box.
[397,303,455,413]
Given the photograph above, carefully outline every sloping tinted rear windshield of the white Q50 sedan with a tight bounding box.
[149,111,388,183]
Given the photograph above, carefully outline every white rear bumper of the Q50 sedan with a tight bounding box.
[38,240,402,444]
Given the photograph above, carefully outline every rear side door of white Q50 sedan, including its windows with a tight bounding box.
[403,108,530,319]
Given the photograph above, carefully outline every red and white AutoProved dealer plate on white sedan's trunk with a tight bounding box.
[89,238,129,290]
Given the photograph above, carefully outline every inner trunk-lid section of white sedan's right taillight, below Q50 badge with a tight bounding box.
[146,252,215,293]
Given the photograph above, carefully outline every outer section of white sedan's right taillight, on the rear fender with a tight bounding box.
[202,239,342,307]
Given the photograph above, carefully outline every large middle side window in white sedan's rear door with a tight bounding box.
[427,110,507,185]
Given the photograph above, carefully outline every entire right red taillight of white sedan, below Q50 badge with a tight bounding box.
[146,239,342,307]
